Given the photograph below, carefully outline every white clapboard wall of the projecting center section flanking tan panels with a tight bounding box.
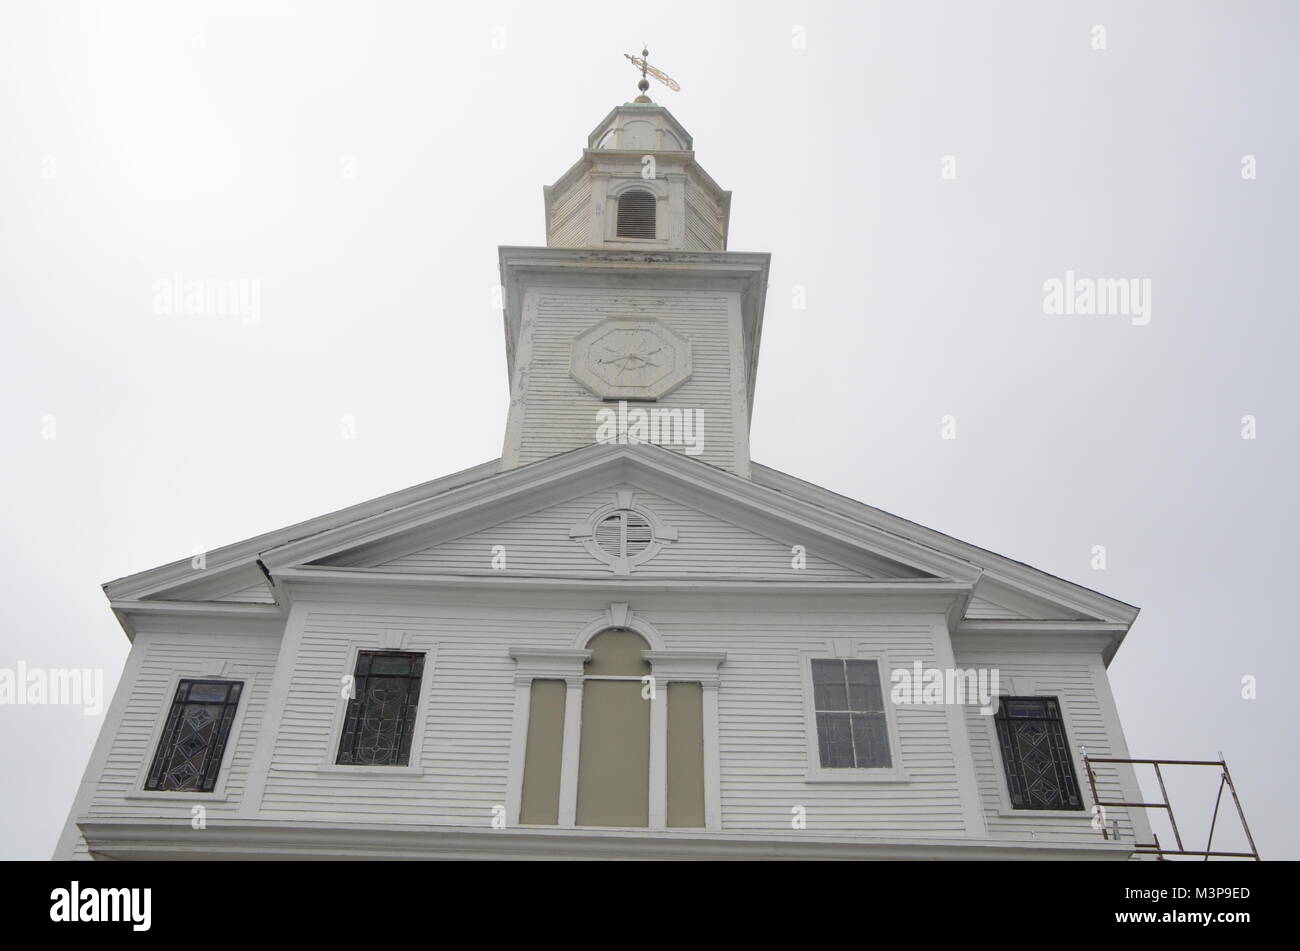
[261,604,963,835]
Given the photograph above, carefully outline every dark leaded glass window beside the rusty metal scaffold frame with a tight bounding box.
[995,696,1083,809]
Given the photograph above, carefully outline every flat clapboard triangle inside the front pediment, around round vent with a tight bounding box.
[317,483,924,581]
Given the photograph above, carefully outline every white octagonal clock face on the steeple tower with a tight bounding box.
[569,318,692,400]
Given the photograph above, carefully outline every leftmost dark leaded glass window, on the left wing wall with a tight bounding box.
[144,681,243,793]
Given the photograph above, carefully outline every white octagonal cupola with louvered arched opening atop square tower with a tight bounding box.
[542,101,731,251]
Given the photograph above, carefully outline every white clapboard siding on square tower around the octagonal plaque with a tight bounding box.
[519,288,745,469]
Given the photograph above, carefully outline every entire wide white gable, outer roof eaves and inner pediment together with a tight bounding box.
[105,446,1138,641]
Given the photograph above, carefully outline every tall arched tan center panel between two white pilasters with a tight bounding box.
[577,628,650,828]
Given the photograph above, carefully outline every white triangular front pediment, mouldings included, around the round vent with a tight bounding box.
[263,446,956,582]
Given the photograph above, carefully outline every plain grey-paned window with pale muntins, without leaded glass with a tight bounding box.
[813,659,893,769]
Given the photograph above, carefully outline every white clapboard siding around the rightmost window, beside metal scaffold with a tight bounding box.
[957,652,1134,842]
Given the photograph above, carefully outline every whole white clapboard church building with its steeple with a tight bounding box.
[56,90,1151,859]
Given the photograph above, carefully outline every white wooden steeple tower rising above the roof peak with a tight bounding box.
[499,71,770,477]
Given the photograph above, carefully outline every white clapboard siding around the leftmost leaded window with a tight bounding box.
[76,631,280,817]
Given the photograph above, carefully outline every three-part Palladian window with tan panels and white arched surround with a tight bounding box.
[508,615,727,830]
